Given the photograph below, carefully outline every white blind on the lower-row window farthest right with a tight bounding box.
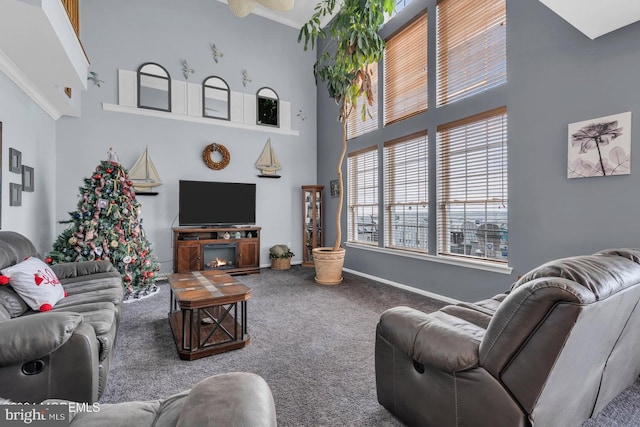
[437,107,508,262]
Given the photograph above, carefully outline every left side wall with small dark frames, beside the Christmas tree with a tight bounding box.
[0,72,56,253]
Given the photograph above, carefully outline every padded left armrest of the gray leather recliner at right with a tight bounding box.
[378,307,484,373]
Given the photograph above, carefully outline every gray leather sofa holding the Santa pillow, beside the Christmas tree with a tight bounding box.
[0,231,123,403]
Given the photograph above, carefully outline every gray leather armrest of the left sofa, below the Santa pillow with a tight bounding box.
[0,311,82,366]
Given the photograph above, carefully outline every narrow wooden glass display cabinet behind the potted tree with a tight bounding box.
[302,185,324,267]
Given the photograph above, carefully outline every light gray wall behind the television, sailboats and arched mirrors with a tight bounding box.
[56,0,316,272]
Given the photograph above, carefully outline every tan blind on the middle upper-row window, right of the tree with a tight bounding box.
[384,12,427,126]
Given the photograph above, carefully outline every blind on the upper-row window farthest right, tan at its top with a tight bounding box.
[437,0,507,106]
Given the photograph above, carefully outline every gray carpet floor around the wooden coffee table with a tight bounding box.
[101,266,640,427]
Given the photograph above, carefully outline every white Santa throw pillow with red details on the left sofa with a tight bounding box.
[0,257,66,311]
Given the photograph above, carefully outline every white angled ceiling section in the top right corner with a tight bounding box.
[540,0,640,39]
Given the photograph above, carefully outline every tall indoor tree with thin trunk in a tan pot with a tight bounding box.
[298,0,395,285]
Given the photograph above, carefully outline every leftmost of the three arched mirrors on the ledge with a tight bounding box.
[138,62,171,111]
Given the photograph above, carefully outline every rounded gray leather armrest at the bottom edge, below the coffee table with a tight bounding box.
[176,372,277,427]
